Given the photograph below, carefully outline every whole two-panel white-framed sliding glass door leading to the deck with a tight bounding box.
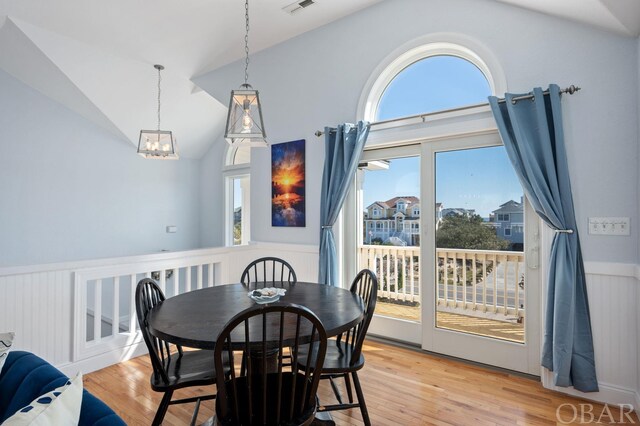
[357,134,540,374]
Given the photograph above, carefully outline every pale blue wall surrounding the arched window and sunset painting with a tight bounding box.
[197,0,639,264]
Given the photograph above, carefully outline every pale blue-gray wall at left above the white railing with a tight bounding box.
[0,71,200,267]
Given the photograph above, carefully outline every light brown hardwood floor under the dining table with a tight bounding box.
[84,341,640,426]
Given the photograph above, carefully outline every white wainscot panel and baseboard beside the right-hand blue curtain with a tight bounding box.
[542,262,640,410]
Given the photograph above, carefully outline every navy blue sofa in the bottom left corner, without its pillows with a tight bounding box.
[0,351,126,426]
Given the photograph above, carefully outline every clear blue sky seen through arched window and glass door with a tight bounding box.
[363,56,522,218]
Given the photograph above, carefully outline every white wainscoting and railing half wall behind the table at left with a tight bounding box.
[0,243,318,375]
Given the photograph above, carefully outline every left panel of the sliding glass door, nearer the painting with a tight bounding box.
[357,146,422,344]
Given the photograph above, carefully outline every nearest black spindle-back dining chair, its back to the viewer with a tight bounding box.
[214,303,327,426]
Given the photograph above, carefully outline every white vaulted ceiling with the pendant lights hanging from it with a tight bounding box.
[0,0,640,158]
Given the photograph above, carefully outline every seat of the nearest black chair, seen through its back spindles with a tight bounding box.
[216,373,318,426]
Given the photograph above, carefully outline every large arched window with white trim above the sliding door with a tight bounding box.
[358,42,506,122]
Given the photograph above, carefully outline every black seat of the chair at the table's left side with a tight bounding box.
[151,350,216,392]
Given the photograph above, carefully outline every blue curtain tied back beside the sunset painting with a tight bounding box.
[318,121,369,286]
